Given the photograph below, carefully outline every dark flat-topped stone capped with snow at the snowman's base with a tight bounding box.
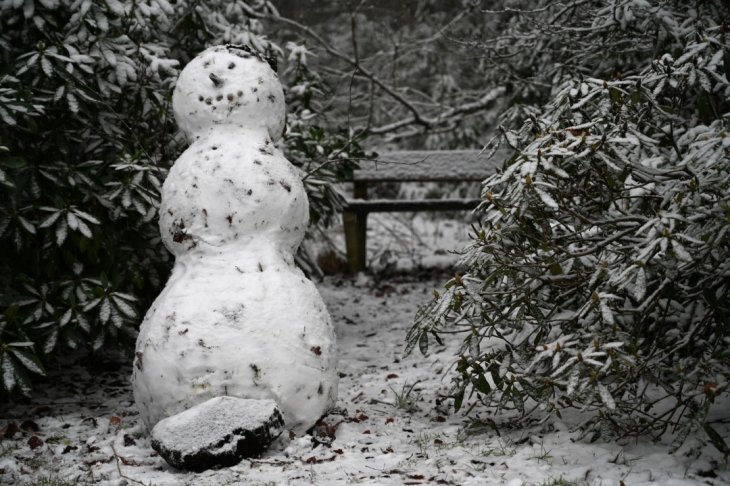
[152,397,284,471]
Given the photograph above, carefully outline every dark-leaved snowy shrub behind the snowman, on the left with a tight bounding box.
[0,0,359,394]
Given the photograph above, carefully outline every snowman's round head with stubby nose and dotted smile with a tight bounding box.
[172,46,285,141]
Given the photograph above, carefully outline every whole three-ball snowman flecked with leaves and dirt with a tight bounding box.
[133,46,337,434]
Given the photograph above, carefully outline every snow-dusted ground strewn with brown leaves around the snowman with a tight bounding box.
[0,215,730,486]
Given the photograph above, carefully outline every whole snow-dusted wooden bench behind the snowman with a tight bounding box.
[342,150,503,272]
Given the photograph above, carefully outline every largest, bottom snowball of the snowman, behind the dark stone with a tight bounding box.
[133,259,337,434]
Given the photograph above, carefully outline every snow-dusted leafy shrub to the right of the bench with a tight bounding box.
[408,0,730,452]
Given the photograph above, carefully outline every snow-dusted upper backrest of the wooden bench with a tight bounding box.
[353,150,505,182]
